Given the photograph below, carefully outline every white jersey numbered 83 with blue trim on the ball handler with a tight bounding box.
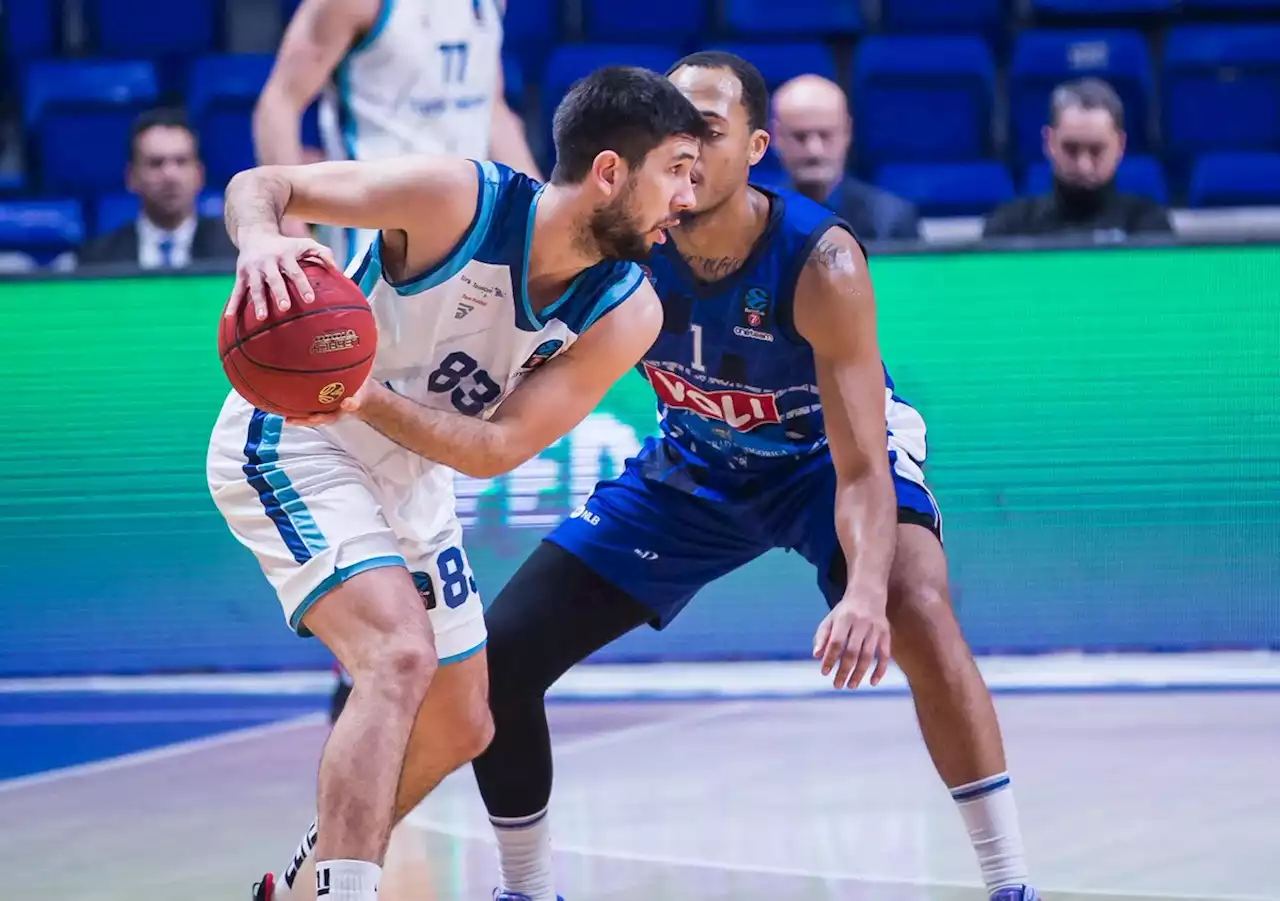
[326,163,644,499]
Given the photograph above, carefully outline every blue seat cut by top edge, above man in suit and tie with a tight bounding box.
[86,0,216,58]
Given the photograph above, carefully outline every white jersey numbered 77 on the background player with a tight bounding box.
[320,0,502,160]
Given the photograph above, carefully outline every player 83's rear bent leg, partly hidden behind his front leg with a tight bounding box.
[276,651,493,901]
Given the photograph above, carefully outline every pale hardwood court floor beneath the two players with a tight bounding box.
[0,691,1280,901]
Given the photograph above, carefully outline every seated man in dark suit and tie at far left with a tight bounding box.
[78,110,236,269]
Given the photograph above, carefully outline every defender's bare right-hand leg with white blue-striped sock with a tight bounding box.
[888,523,1028,893]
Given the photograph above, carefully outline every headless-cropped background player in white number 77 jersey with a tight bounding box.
[253,0,541,264]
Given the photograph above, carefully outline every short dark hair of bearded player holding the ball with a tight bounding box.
[552,67,708,184]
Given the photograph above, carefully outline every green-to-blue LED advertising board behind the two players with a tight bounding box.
[0,247,1280,673]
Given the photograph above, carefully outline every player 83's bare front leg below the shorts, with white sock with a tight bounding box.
[302,567,436,901]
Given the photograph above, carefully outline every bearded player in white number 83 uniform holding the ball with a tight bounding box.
[207,68,705,901]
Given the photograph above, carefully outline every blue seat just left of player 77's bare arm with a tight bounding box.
[187,54,273,186]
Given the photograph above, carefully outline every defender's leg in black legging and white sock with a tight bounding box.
[472,541,653,901]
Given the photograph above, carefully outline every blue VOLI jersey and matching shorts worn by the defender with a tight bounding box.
[547,181,941,619]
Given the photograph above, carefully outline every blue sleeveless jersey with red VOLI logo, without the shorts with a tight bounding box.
[639,188,892,493]
